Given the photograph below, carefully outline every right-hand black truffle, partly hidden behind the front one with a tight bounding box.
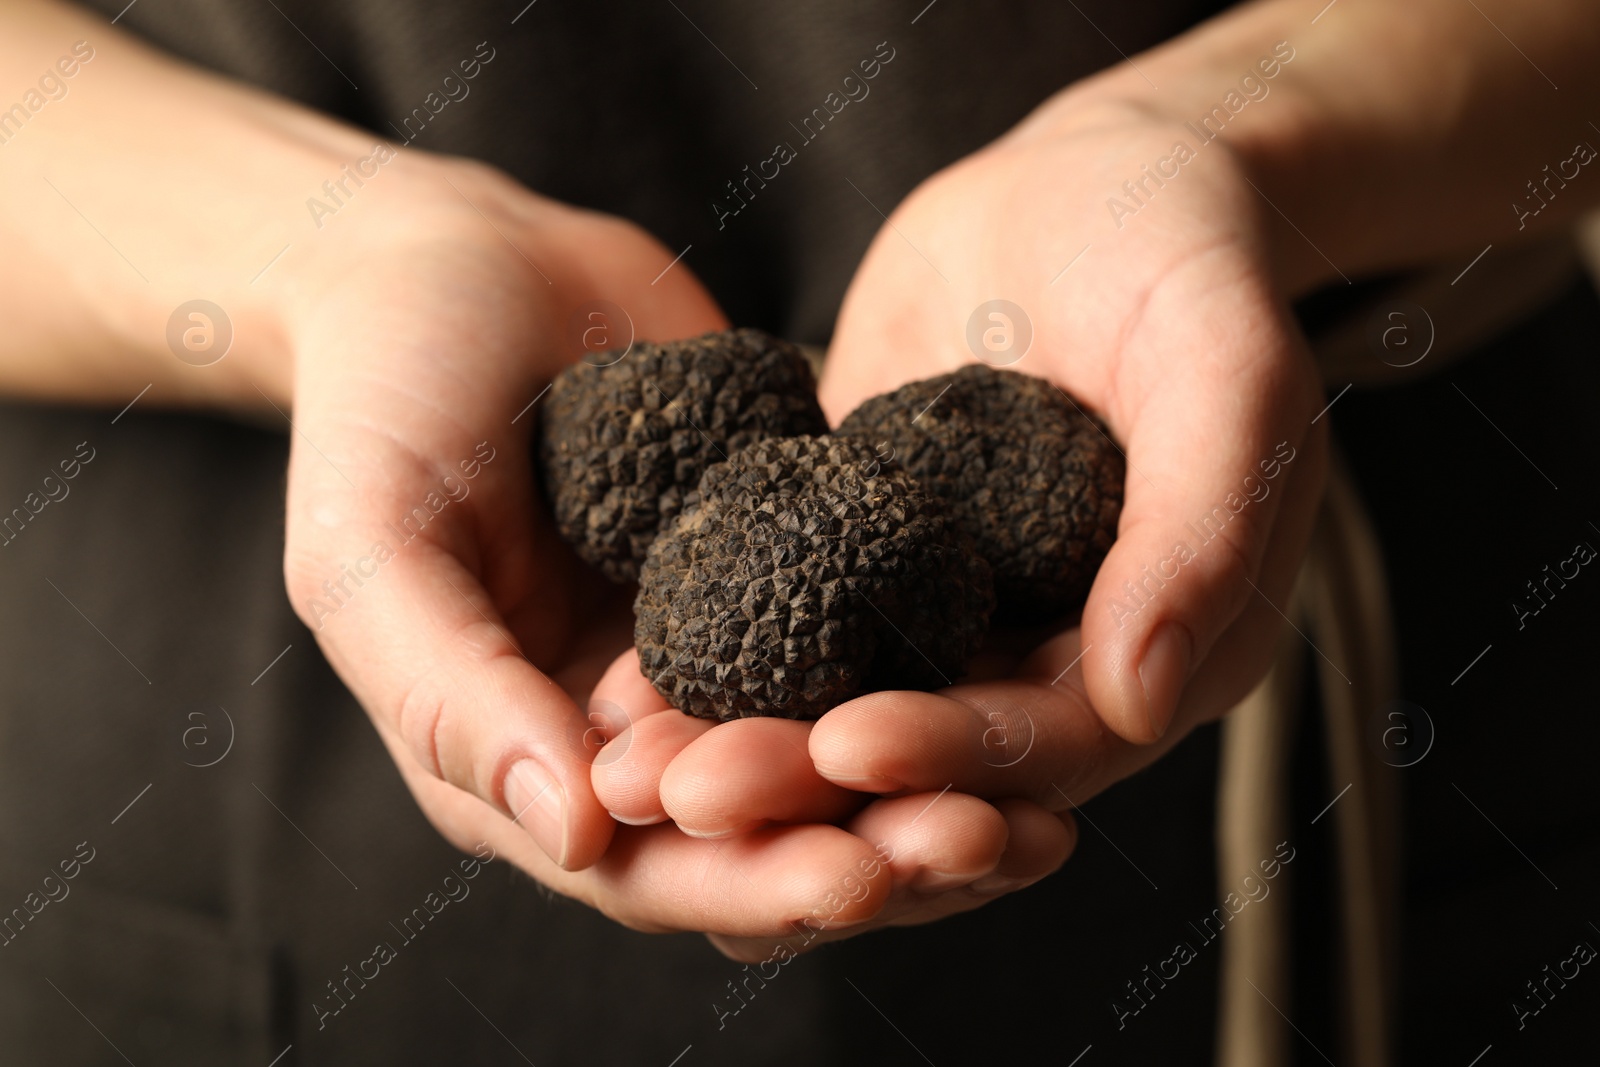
[838,365,1125,619]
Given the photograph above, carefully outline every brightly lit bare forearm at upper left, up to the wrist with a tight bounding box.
[0,3,390,408]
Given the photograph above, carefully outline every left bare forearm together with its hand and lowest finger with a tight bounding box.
[0,0,1024,937]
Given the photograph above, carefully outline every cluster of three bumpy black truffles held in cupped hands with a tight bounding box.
[539,330,1123,720]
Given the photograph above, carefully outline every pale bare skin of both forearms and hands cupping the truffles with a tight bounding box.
[0,0,1600,958]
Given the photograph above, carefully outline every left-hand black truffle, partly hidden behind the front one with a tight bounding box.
[539,330,827,582]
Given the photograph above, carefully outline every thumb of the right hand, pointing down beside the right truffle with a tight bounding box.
[1083,253,1320,742]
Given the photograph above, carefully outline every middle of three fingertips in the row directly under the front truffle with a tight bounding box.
[661,718,867,838]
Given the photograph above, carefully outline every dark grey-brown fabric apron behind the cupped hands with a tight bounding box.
[0,0,1600,1067]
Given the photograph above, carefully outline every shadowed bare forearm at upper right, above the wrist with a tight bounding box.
[1046,0,1600,293]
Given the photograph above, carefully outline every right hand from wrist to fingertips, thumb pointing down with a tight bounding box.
[642,98,1326,870]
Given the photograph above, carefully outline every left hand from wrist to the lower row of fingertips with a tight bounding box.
[280,155,1070,958]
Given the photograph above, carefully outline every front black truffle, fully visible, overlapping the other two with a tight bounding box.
[634,437,994,720]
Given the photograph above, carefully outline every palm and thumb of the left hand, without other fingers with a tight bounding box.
[278,152,726,870]
